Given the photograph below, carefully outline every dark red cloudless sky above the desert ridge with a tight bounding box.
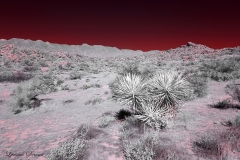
[0,0,240,51]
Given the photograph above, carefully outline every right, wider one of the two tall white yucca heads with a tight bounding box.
[148,70,193,107]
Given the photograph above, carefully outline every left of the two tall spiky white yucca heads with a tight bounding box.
[112,73,147,111]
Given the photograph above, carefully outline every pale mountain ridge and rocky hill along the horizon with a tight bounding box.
[0,38,240,57]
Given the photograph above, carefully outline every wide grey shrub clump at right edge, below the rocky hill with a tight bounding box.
[199,57,240,81]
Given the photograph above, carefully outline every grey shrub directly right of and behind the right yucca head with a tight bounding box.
[187,73,208,97]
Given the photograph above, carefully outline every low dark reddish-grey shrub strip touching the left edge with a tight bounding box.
[0,71,32,82]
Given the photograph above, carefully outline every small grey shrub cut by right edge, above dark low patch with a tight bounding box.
[225,81,240,103]
